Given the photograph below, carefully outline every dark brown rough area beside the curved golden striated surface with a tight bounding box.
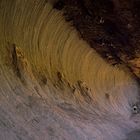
[54,0,140,80]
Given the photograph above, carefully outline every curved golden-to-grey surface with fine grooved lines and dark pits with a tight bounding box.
[0,0,140,140]
